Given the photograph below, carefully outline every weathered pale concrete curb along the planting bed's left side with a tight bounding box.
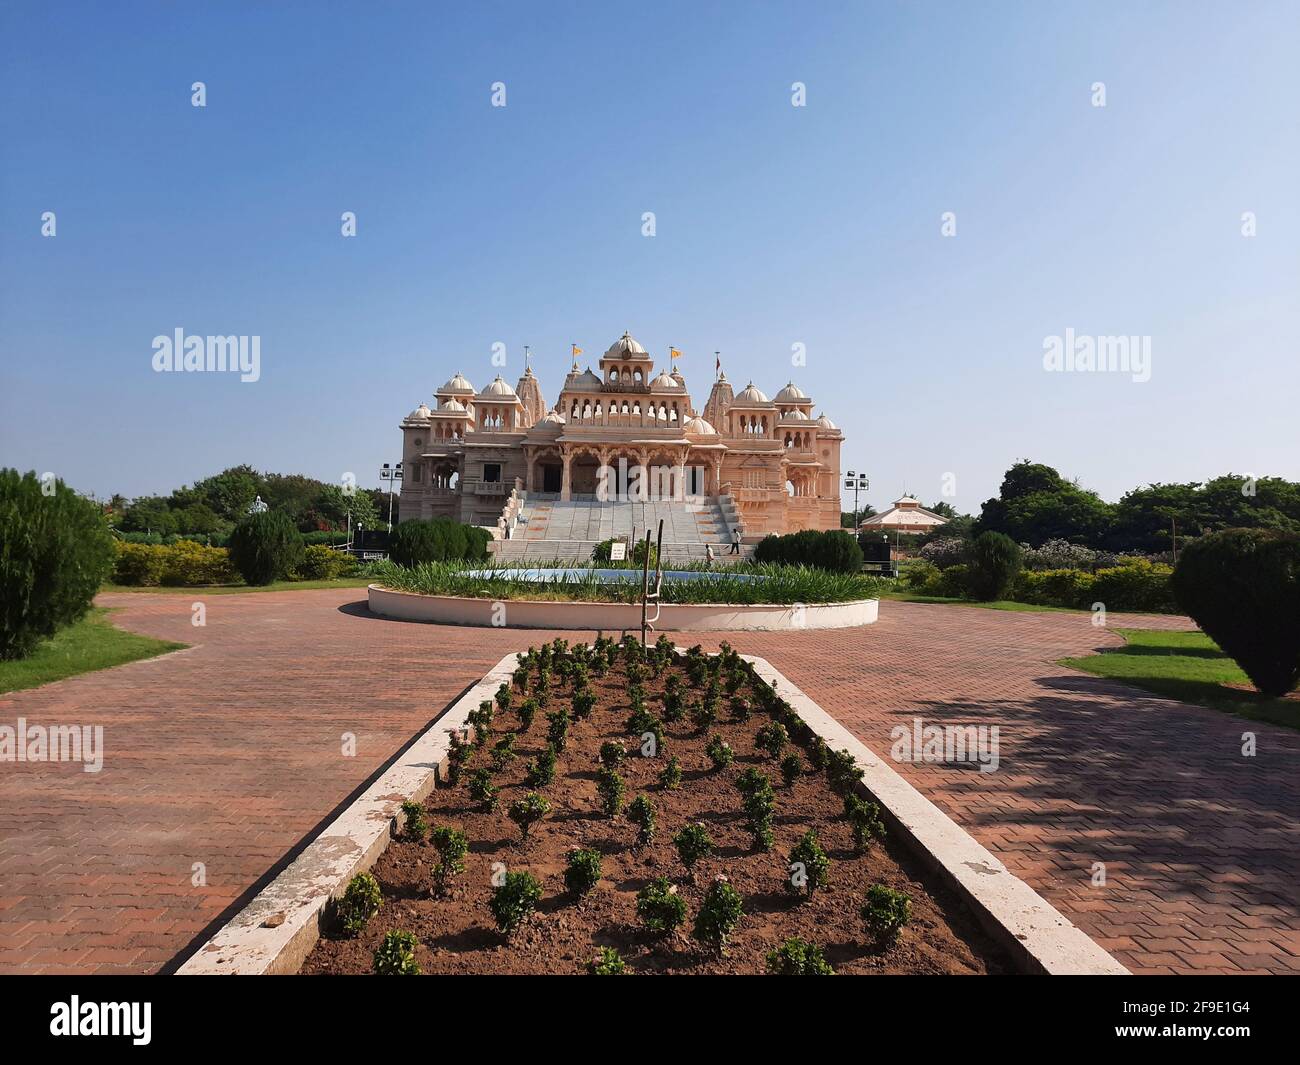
[177,654,517,977]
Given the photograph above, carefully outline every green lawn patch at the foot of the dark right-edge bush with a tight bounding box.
[1060,628,1300,728]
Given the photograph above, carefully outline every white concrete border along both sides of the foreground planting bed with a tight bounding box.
[177,654,1128,975]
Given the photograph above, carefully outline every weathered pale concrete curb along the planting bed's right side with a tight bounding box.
[741,654,1128,975]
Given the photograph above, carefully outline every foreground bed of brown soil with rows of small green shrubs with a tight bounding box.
[302,638,1010,973]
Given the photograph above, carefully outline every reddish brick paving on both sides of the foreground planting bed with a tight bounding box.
[0,589,1300,973]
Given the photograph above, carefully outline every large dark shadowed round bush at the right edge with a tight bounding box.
[1173,529,1300,696]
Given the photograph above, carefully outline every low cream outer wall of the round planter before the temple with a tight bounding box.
[369,584,880,632]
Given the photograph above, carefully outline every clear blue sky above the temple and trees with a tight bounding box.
[0,3,1300,510]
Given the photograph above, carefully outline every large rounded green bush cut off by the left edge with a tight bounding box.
[0,469,116,658]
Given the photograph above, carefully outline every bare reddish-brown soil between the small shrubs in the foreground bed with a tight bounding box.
[302,644,1013,974]
